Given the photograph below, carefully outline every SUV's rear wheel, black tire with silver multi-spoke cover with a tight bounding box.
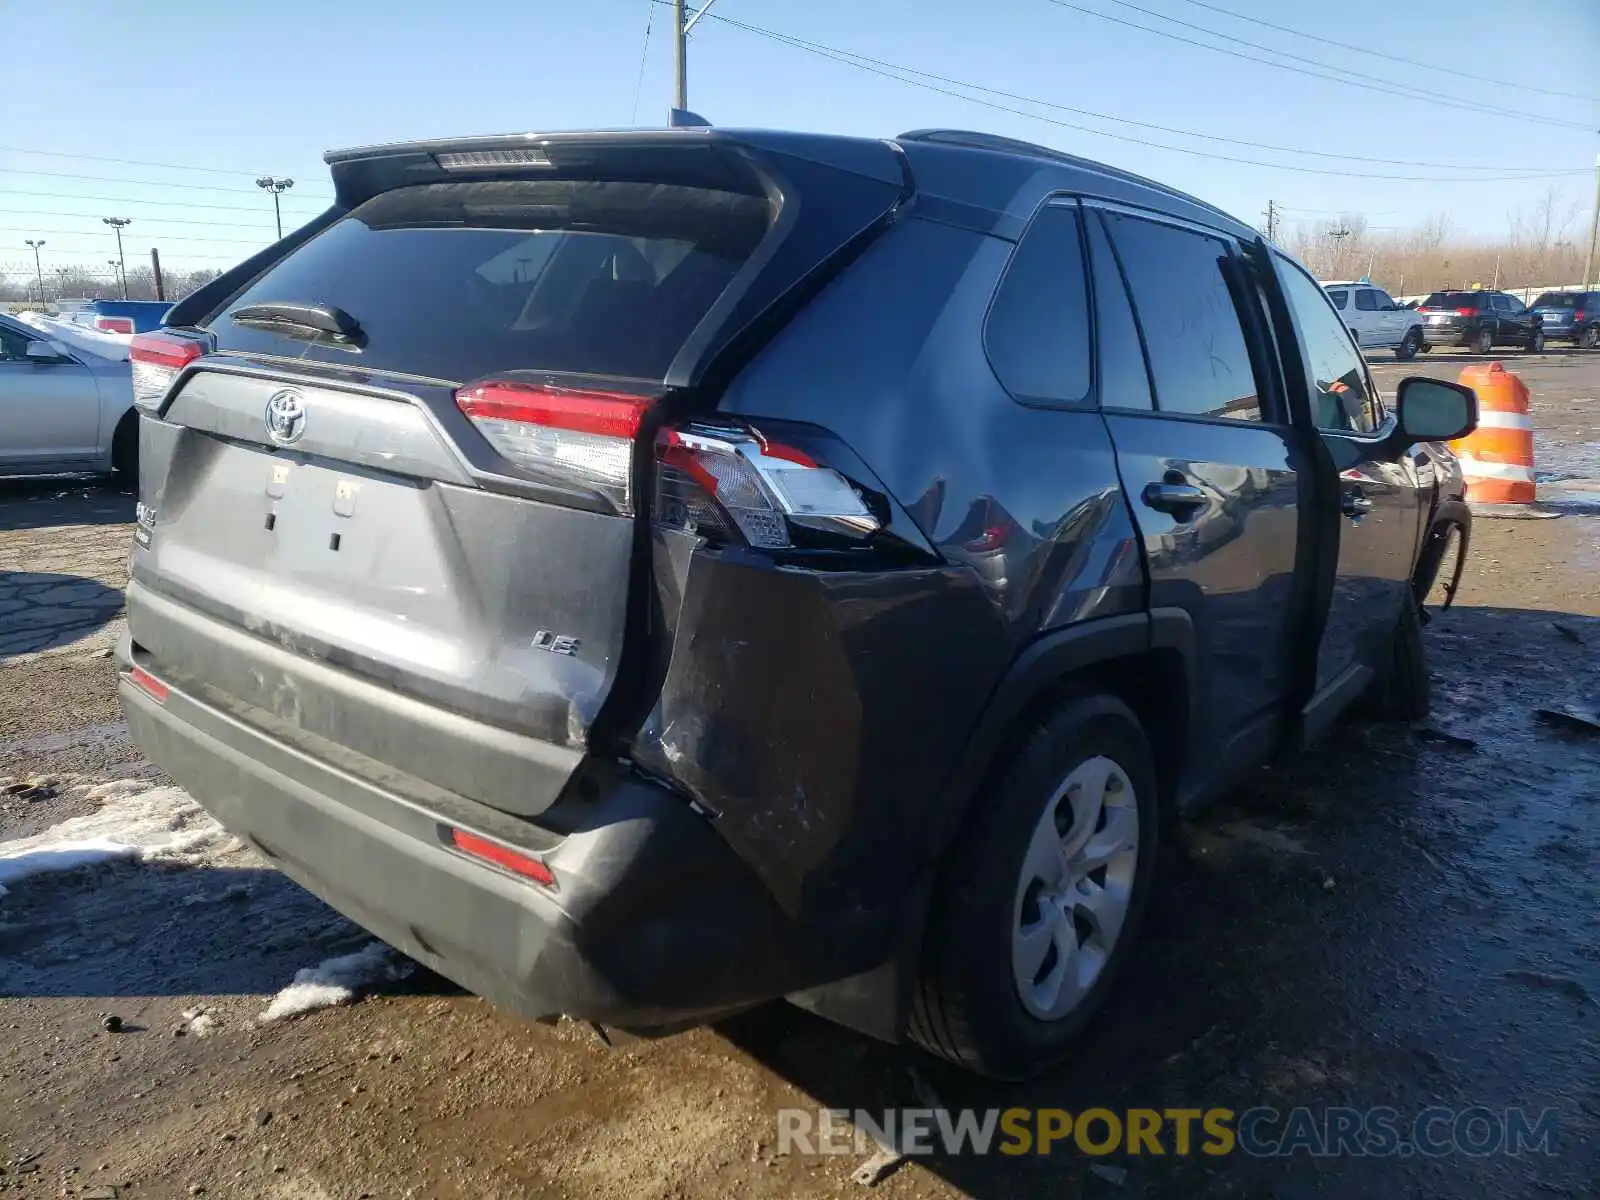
[910,691,1160,1080]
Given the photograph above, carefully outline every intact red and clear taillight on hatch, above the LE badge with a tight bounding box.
[456,381,650,514]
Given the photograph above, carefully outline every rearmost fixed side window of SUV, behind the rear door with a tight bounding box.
[984,205,1090,405]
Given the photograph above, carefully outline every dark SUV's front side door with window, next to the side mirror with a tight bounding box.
[1277,256,1422,717]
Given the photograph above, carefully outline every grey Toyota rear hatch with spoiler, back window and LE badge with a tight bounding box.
[130,131,902,814]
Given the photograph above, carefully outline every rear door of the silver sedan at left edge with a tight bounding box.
[0,320,99,469]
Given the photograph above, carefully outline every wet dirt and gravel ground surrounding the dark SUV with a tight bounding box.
[0,354,1600,1200]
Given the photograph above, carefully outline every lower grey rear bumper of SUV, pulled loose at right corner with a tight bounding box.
[118,640,842,1027]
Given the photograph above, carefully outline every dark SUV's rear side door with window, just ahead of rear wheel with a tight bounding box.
[1088,208,1312,790]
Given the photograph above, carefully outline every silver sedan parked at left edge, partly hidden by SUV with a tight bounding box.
[0,315,139,478]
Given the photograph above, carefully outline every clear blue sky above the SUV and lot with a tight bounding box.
[0,0,1600,280]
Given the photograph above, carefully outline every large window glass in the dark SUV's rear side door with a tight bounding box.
[1106,213,1261,421]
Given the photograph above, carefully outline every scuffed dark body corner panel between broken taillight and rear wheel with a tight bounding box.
[634,544,1006,914]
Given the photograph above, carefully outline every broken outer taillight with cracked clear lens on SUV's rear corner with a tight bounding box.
[654,426,878,550]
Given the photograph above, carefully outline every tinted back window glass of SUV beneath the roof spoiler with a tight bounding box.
[210,179,774,382]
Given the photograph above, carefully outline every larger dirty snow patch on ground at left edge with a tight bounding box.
[0,779,242,896]
